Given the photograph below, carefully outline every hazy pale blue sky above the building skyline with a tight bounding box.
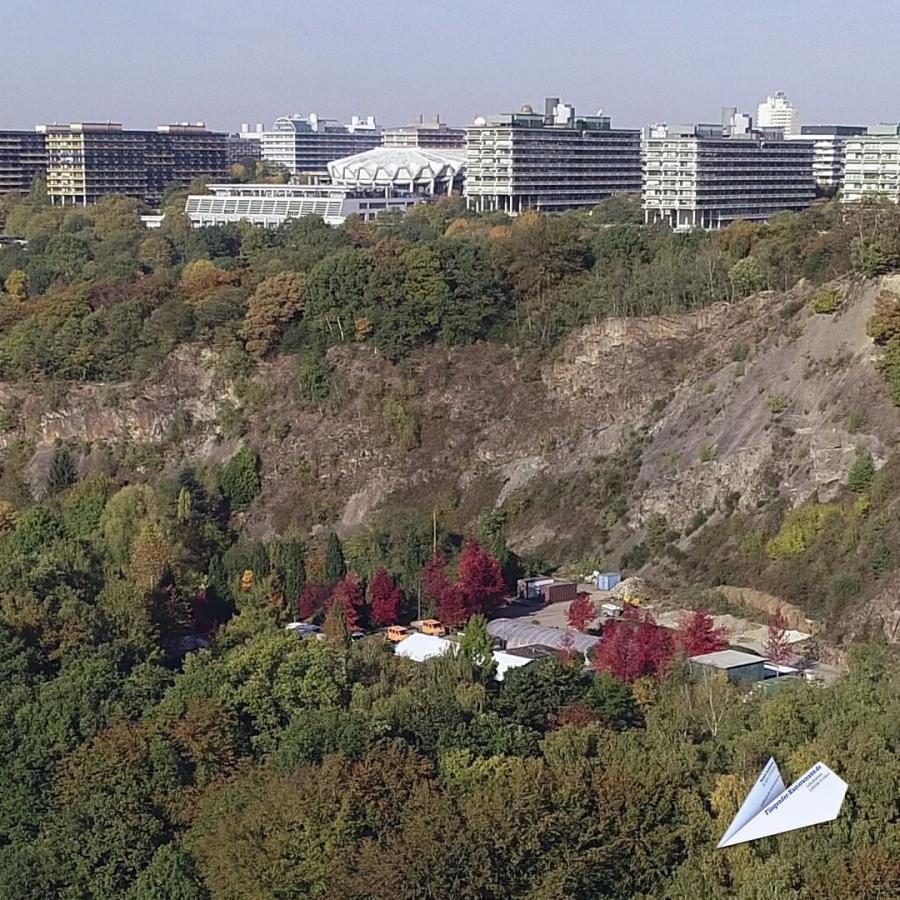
[7,0,900,129]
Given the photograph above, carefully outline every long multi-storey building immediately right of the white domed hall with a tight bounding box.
[465,97,641,215]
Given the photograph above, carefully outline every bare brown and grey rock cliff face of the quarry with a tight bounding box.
[0,282,900,631]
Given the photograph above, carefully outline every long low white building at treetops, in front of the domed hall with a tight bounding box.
[184,184,424,228]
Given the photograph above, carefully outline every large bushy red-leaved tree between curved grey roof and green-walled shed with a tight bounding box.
[592,607,674,683]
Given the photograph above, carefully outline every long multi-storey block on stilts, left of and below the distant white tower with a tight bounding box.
[642,109,816,229]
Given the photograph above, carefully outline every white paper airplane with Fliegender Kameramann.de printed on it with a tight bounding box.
[719,759,847,848]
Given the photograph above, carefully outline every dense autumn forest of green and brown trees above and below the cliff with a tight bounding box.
[0,185,900,900]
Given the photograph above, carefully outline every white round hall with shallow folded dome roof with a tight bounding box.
[328,147,466,194]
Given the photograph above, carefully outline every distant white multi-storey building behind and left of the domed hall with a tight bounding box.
[260,113,381,175]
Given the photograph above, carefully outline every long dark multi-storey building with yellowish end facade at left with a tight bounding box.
[41,122,227,206]
